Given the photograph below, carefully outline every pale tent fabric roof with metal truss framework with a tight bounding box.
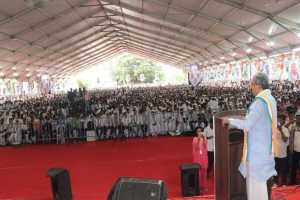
[0,0,300,78]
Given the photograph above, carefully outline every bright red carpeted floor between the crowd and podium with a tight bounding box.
[0,137,300,200]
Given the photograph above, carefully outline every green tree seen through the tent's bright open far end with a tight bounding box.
[113,55,165,85]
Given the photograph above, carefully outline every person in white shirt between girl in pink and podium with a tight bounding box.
[204,119,215,172]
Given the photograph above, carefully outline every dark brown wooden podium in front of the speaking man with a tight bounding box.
[214,110,247,200]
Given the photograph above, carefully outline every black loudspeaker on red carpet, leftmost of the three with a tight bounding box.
[48,168,72,200]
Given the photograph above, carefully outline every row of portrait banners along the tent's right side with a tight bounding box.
[199,52,300,81]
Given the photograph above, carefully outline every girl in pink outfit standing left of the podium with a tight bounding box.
[193,128,208,191]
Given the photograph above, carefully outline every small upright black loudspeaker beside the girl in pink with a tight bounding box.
[180,163,200,197]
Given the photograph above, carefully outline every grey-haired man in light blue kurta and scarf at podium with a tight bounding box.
[223,73,277,200]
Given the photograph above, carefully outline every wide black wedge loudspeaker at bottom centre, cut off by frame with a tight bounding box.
[107,177,167,200]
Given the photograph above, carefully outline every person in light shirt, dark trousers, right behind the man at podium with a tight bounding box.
[275,114,290,186]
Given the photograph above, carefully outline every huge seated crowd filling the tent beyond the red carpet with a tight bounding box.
[0,82,300,145]
